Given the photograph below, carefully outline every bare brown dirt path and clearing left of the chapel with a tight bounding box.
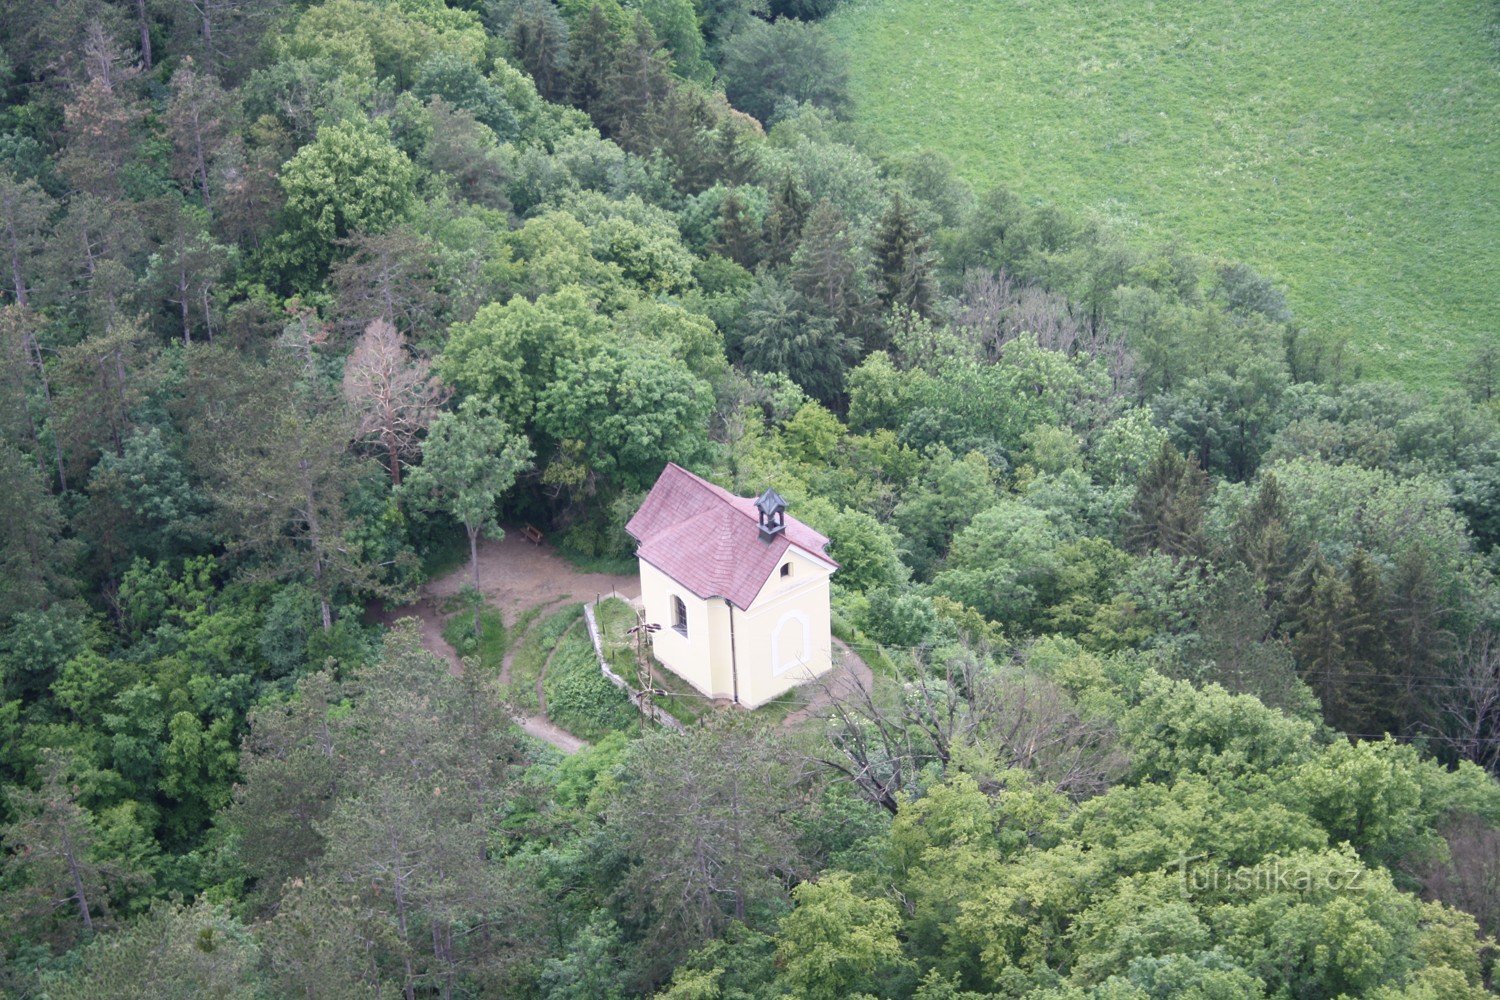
[375,528,641,754]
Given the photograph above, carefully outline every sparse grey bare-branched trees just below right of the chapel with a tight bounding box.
[809,651,1124,814]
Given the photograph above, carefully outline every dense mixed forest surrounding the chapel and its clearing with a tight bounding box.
[0,0,1500,1000]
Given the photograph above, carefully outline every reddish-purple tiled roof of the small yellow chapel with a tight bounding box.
[626,462,837,610]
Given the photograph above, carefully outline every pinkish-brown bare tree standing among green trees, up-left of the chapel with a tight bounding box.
[344,319,449,486]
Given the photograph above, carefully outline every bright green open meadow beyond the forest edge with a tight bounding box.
[830,0,1500,387]
